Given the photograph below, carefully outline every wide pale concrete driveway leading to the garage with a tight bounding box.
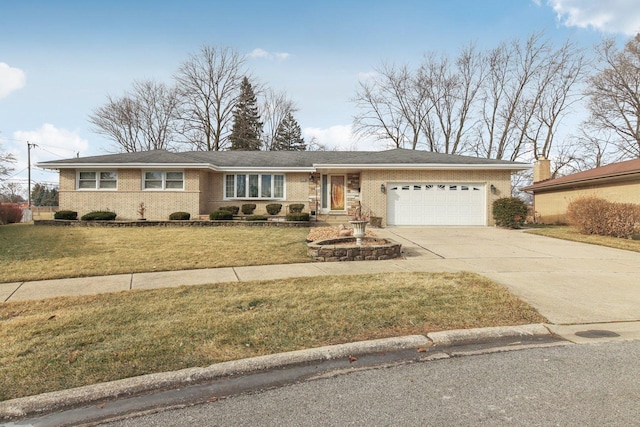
[376,227,640,325]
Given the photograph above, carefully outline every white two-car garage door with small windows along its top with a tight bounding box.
[387,183,486,225]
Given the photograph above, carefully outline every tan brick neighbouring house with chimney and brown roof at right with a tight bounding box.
[522,159,640,224]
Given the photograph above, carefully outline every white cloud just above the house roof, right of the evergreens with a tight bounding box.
[302,125,392,151]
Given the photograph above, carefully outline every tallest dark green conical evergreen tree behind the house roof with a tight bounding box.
[229,77,262,150]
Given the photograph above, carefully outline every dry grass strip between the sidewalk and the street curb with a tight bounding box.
[0,273,545,400]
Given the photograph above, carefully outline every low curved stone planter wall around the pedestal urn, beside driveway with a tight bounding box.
[307,237,402,262]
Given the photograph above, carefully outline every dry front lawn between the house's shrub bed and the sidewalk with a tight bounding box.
[0,224,310,283]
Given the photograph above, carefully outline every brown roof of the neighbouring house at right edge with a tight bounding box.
[523,159,640,192]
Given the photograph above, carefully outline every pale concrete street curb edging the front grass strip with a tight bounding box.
[0,324,551,420]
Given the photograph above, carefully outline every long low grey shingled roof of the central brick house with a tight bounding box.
[38,148,530,170]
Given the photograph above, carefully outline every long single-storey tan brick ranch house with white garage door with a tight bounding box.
[38,149,530,225]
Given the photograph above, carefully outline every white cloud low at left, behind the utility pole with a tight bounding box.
[8,123,89,181]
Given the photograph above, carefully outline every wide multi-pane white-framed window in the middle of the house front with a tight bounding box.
[224,173,284,199]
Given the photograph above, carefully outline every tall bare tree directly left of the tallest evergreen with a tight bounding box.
[174,45,246,151]
